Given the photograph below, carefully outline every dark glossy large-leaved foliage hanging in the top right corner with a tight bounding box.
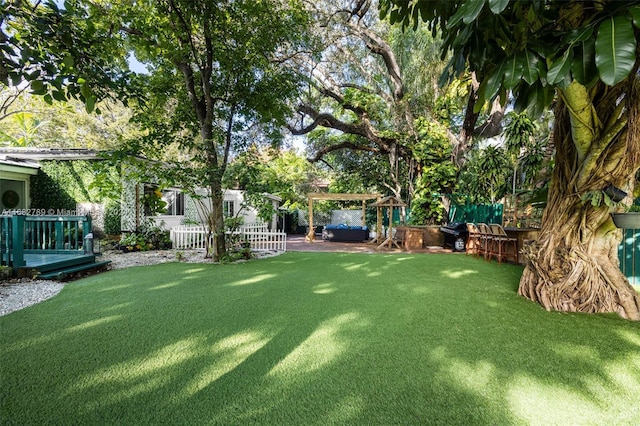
[380,0,640,117]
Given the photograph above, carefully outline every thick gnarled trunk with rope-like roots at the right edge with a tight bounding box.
[518,78,640,321]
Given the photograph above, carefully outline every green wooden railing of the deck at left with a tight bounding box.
[0,215,91,268]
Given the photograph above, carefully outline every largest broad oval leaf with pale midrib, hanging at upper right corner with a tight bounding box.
[596,16,636,86]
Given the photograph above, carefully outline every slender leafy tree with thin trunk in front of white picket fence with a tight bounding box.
[110,0,304,260]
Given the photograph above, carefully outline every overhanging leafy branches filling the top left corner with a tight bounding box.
[0,0,141,112]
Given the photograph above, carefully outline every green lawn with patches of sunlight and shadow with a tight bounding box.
[0,253,640,425]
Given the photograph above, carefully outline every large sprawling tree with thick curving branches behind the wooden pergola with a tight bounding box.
[290,0,503,222]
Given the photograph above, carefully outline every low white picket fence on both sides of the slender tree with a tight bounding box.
[170,224,287,252]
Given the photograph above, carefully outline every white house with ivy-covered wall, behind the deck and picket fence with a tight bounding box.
[0,148,282,234]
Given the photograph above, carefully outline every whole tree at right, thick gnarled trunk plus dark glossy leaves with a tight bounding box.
[381,0,640,321]
